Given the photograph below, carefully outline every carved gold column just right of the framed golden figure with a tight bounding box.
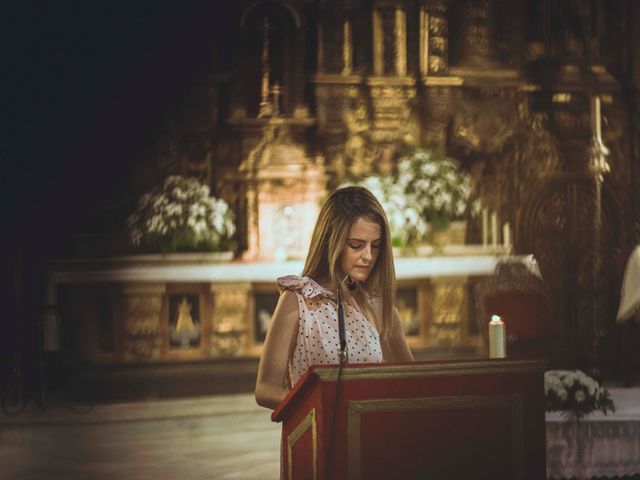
[211,282,251,356]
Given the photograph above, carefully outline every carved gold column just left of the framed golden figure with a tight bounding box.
[123,283,166,361]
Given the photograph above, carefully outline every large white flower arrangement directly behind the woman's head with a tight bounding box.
[350,149,477,247]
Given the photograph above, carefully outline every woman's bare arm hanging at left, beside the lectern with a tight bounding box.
[255,290,299,409]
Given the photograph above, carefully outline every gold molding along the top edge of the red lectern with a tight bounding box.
[314,360,545,382]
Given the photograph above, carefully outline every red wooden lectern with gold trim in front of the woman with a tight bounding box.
[271,359,546,480]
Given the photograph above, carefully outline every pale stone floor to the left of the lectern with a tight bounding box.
[0,394,280,480]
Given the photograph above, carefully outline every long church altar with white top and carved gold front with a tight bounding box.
[44,247,539,365]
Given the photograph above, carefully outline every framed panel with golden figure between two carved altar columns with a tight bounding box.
[169,294,201,349]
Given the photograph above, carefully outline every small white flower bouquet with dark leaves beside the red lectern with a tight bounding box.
[544,370,615,420]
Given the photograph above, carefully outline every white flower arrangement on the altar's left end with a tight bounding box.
[127,175,235,252]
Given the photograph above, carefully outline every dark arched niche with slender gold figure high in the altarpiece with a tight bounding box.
[241,2,295,118]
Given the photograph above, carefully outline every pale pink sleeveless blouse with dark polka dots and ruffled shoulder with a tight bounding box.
[276,275,382,387]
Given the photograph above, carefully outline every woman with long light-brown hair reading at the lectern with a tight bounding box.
[255,187,413,409]
